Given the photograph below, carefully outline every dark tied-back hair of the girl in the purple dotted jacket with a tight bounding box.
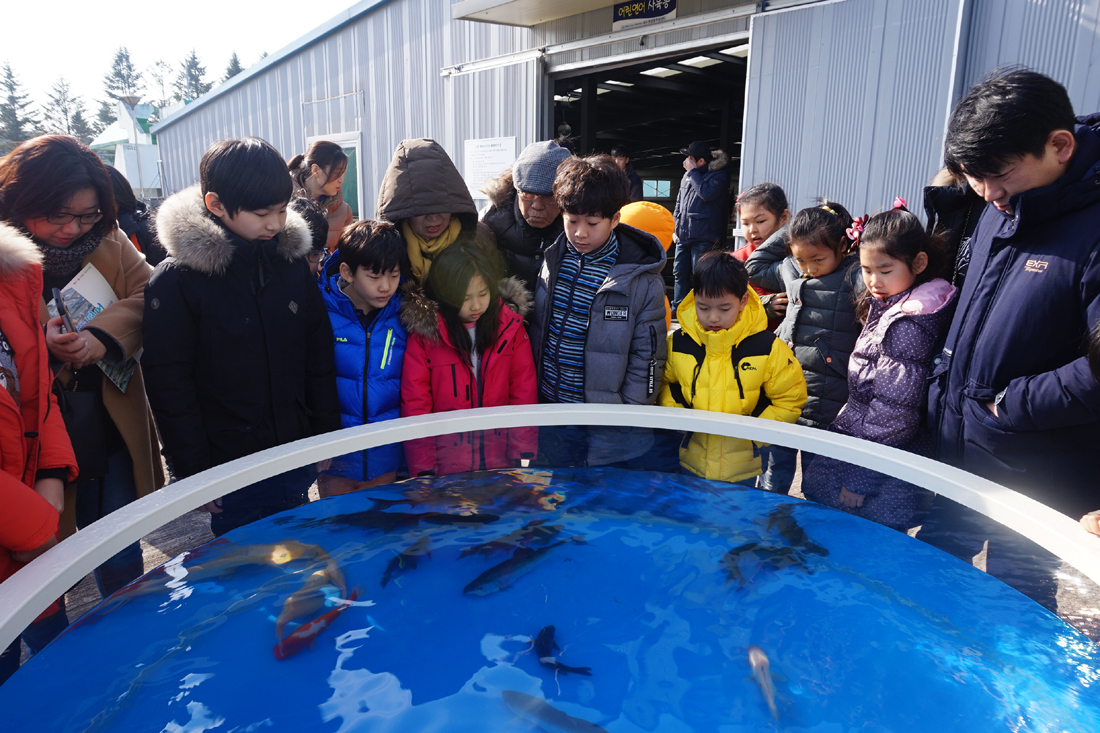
[856,208,947,322]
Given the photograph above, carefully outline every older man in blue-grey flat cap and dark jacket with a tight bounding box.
[482,140,572,292]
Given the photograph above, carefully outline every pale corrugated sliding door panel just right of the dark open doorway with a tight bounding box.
[740,0,960,216]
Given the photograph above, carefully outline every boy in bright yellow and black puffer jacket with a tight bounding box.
[658,252,806,485]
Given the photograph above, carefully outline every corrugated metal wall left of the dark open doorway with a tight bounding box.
[157,0,547,214]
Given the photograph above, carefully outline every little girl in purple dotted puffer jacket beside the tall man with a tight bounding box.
[802,198,956,532]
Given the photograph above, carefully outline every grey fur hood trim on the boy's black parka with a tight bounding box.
[156,185,314,275]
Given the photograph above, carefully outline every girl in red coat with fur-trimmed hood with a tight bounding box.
[402,236,538,475]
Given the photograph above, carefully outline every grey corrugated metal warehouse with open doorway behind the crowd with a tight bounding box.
[154,0,1100,217]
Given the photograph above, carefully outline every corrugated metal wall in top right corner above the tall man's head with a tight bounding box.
[964,0,1100,114]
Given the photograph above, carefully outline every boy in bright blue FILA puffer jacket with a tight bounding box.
[317,215,408,490]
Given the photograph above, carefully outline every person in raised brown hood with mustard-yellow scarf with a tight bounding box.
[376,140,496,284]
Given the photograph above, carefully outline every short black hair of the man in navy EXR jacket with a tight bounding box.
[944,67,1077,178]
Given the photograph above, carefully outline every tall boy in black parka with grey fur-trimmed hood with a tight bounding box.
[142,138,340,535]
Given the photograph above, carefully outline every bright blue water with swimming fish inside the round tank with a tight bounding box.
[0,411,1100,733]
